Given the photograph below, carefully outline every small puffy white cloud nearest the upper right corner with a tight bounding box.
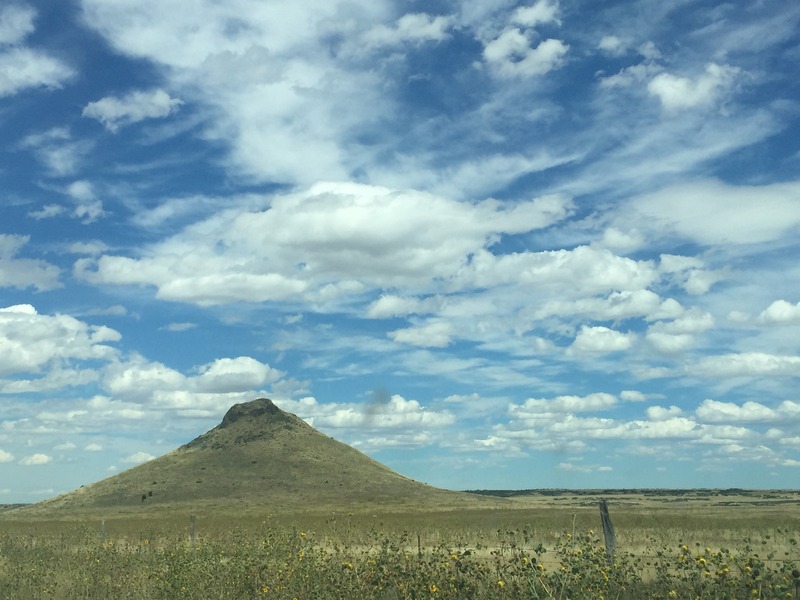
[647,63,741,111]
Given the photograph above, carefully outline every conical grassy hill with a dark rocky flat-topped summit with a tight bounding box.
[11,398,490,515]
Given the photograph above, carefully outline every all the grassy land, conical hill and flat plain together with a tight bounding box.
[0,399,800,600]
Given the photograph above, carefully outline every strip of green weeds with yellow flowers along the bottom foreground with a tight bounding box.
[0,516,800,600]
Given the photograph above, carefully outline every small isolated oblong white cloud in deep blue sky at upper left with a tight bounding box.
[82,89,183,132]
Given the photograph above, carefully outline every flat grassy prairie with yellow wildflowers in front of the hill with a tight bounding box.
[0,495,800,600]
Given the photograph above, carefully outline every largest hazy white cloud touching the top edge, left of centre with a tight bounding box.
[82,0,390,184]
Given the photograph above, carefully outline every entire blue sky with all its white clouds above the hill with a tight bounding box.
[0,0,800,502]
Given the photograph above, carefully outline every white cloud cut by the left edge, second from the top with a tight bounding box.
[0,47,75,98]
